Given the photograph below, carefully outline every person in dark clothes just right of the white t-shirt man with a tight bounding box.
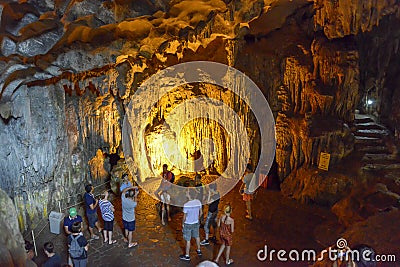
[200,183,220,246]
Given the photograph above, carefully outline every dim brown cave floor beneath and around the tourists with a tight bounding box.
[32,185,350,266]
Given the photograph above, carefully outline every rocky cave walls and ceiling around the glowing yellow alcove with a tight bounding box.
[0,0,400,266]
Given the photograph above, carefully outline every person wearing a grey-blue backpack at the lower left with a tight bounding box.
[68,222,89,267]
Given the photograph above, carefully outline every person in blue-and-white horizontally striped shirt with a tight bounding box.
[99,191,117,245]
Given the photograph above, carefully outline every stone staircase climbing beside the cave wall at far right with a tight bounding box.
[353,114,400,177]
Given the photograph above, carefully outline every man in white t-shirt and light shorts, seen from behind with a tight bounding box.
[179,189,203,261]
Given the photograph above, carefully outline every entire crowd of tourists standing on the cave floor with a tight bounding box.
[32,164,255,267]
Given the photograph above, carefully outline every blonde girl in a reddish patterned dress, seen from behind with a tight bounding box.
[215,204,234,265]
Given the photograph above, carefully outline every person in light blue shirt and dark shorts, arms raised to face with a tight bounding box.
[121,186,139,248]
